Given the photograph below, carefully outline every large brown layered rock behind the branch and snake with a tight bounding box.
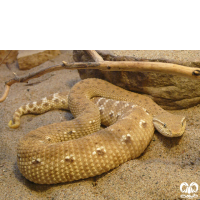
[74,50,200,110]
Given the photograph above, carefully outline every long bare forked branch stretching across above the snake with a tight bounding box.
[0,50,200,102]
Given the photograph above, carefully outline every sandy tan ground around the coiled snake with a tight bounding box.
[0,51,200,200]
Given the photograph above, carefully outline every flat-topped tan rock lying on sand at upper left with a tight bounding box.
[17,50,60,70]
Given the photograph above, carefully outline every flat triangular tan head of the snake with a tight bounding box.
[153,113,186,137]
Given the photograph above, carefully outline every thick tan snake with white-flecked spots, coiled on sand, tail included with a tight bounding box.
[8,78,186,184]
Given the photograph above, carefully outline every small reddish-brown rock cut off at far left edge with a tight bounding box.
[0,50,18,64]
